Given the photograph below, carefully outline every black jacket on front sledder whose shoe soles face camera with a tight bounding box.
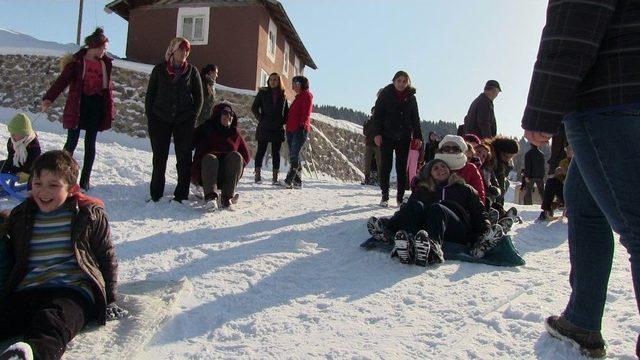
[409,183,490,244]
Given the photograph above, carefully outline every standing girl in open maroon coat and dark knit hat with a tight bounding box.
[41,27,115,191]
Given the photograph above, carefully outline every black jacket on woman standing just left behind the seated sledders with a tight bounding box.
[372,84,422,143]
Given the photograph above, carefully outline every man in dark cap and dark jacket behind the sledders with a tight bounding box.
[464,80,502,139]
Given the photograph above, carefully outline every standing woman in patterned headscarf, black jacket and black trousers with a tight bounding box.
[144,38,202,202]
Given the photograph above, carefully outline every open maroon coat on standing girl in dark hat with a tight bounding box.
[43,49,115,131]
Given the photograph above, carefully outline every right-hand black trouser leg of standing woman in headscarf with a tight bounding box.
[173,121,193,201]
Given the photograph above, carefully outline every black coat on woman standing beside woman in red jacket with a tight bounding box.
[251,88,289,142]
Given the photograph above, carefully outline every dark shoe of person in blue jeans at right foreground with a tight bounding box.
[544,316,607,358]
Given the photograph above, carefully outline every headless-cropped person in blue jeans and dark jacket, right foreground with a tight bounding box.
[522,0,640,357]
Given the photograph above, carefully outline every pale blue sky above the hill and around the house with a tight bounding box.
[0,0,547,136]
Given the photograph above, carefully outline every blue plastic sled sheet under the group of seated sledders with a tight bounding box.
[360,235,525,266]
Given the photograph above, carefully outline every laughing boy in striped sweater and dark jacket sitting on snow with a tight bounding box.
[0,150,126,360]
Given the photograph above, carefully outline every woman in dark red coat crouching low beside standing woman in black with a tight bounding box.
[191,103,251,210]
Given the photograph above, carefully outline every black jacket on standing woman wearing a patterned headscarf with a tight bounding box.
[144,62,203,124]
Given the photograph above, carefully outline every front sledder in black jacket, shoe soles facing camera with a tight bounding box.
[367,159,504,266]
